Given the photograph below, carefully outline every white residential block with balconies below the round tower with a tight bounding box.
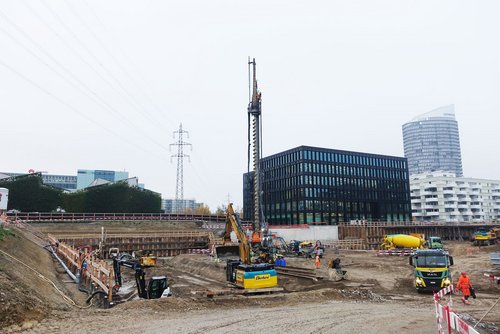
[410,171,500,222]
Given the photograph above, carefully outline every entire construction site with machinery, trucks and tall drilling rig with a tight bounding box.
[0,60,500,334]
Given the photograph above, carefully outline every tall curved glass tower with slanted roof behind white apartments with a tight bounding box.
[403,105,463,177]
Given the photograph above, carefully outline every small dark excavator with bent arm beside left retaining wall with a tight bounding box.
[113,253,171,299]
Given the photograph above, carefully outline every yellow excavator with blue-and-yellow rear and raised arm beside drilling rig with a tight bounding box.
[224,203,278,289]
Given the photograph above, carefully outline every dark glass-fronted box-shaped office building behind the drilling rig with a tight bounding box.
[243,146,411,225]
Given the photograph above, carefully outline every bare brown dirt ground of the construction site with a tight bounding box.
[0,222,500,333]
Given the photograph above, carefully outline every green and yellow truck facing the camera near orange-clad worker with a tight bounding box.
[409,249,453,292]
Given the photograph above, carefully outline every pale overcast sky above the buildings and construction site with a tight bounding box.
[0,0,500,210]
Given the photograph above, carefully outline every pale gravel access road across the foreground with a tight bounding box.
[17,294,435,334]
